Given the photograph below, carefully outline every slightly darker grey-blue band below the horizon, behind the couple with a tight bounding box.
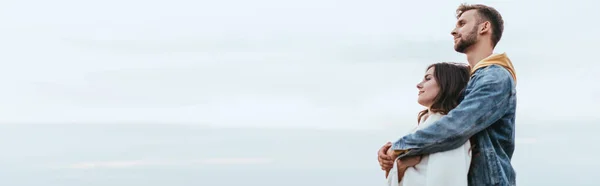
[0,124,600,186]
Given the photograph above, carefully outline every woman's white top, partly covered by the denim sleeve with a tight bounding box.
[387,113,471,186]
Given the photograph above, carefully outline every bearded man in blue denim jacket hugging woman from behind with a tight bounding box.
[378,4,516,186]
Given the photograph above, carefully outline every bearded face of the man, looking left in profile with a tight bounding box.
[452,10,479,53]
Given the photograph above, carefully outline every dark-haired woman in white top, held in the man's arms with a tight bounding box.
[386,63,471,186]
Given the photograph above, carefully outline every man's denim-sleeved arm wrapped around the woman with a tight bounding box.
[392,66,512,157]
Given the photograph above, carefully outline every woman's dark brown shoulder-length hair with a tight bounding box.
[417,62,471,123]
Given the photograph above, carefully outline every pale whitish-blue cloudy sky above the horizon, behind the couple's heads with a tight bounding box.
[0,0,600,128]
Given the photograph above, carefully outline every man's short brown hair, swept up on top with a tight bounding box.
[456,4,504,47]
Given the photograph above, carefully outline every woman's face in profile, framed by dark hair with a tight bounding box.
[417,67,440,108]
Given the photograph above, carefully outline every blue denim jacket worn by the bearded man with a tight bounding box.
[392,65,517,186]
